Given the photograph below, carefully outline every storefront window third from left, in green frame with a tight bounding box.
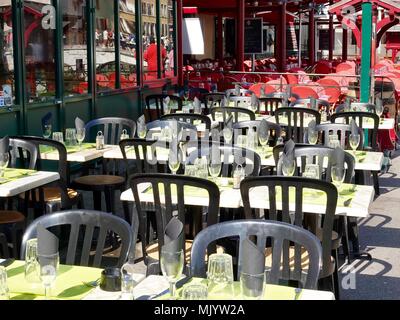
[61,0,88,96]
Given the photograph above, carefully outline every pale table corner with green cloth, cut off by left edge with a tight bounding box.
[0,169,60,198]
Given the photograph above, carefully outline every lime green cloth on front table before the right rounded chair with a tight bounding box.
[156,278,302,300]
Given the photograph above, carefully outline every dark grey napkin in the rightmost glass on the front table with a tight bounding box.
[240,239,265,276]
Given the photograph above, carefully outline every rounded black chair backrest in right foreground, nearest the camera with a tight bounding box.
[191,220,322,289]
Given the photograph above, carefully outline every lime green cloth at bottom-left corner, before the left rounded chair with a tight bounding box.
[7,261,102,300]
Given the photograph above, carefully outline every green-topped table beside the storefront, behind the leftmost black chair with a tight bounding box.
[40,143,118,163]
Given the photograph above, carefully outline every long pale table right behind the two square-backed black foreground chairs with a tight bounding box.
[121,178,375,218]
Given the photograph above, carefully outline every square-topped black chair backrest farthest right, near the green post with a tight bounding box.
[331,112,380,150]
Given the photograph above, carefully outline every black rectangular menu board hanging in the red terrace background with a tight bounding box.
[244,18,263,54]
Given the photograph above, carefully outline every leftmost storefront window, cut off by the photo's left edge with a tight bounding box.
[0,0,15,107]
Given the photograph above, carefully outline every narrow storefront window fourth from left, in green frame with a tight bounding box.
[95,0,116,91]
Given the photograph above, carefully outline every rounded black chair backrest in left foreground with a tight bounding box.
[21,210,134,267]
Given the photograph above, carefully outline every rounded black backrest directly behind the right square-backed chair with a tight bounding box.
[273,144,355,183]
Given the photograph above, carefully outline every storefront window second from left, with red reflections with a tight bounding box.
[24,0,56,103]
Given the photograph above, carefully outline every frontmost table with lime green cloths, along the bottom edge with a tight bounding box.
[0,259,335,300]
